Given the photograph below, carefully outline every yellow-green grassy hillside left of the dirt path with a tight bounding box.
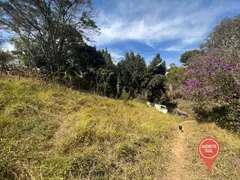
[0,79,181,179]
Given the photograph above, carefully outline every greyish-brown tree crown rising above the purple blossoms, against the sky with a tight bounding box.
[200,14,240,59]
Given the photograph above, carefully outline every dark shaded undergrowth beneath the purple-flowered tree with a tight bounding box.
[194,106,240,132]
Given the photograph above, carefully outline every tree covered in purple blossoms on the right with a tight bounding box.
[184,56,240,118]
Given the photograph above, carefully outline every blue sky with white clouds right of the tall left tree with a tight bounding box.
[89,0,240,65]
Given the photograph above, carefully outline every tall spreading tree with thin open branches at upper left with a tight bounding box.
[0,0,99,74]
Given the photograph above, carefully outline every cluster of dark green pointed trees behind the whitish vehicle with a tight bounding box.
[118,52,166,102]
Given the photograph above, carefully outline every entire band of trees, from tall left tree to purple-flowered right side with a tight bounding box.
[0,0,240,107]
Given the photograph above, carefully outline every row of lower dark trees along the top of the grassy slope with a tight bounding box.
[0,44,166,102]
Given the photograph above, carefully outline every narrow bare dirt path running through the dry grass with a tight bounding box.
[163,120,196,180]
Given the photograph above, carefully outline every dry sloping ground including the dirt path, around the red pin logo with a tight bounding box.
[164,99,240,180]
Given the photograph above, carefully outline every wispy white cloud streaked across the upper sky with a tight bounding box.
[91,0,237,50]
